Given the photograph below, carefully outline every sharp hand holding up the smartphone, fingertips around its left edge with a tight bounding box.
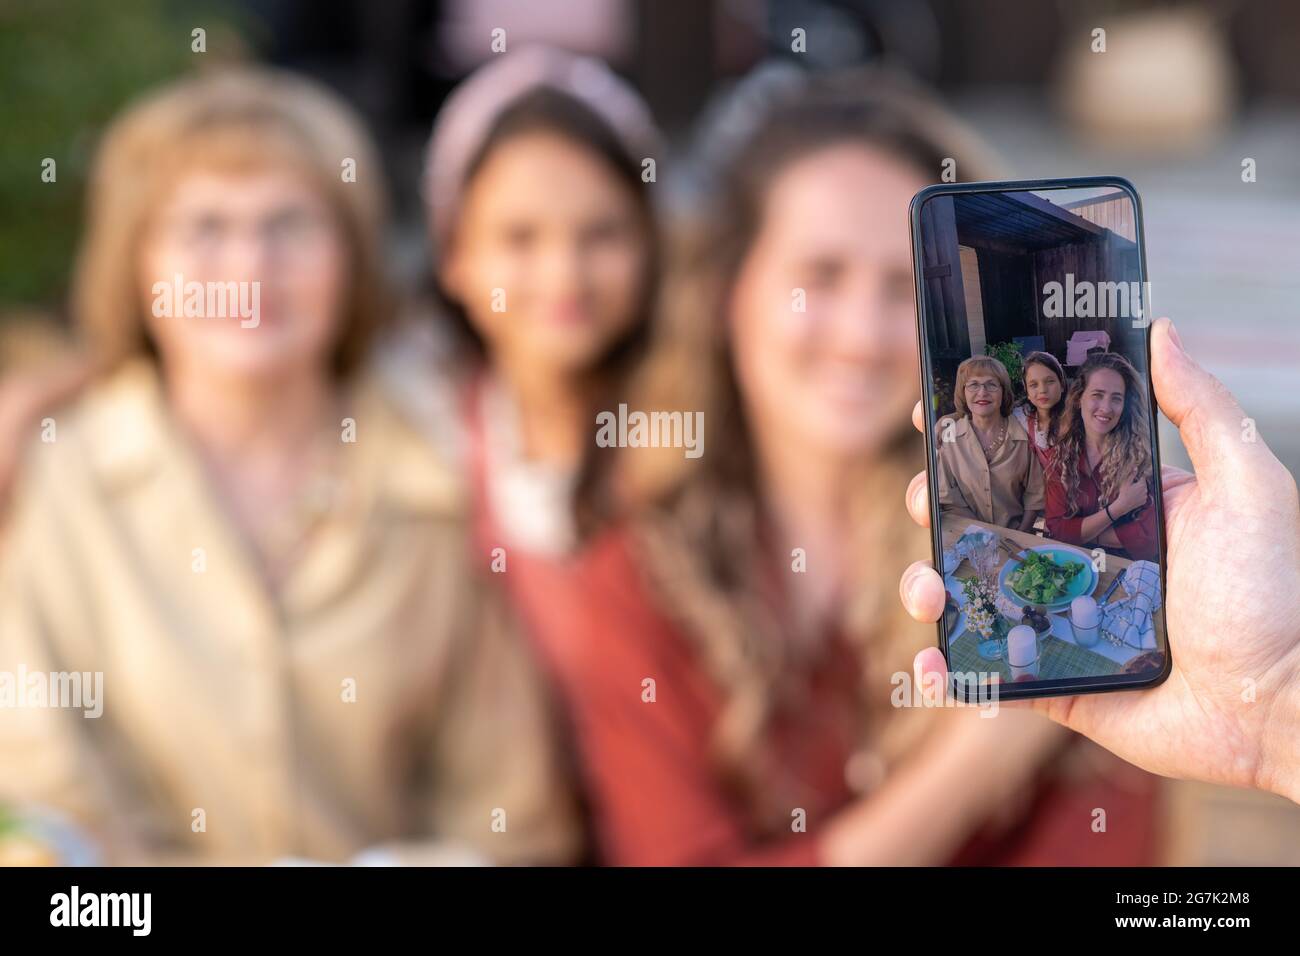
[900,319,1300,803]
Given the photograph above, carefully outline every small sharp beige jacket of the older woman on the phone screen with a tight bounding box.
[935,416,1044,528]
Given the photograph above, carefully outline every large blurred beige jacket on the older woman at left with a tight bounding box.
[0,364,579,862]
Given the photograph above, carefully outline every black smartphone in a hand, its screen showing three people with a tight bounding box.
[910,177,1171,701]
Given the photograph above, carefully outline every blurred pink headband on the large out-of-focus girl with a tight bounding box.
[424,47,659,251]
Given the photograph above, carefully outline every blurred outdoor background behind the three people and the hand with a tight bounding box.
[0,0,1300,864]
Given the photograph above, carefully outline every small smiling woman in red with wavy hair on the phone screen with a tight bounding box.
[1047,352,1160,561]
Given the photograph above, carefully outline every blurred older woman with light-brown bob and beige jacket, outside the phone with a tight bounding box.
[0,70,575,862]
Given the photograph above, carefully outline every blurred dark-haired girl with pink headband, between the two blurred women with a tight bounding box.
[394,47,663,561]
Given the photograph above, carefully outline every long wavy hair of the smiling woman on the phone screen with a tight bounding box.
[1052,352,1152,516]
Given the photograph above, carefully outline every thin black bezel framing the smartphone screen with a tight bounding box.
[907,176,1174,704]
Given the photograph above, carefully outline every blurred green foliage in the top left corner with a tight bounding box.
[0,0,241,314]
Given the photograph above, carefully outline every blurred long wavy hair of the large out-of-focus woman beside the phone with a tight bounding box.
[611,69,997,831]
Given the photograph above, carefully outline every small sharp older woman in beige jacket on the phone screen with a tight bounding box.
[936,355,1044,531]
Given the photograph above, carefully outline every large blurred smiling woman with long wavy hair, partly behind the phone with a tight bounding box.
[511,72,1149,864]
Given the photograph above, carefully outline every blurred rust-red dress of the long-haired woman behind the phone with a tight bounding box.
[469,382,1154,866]
